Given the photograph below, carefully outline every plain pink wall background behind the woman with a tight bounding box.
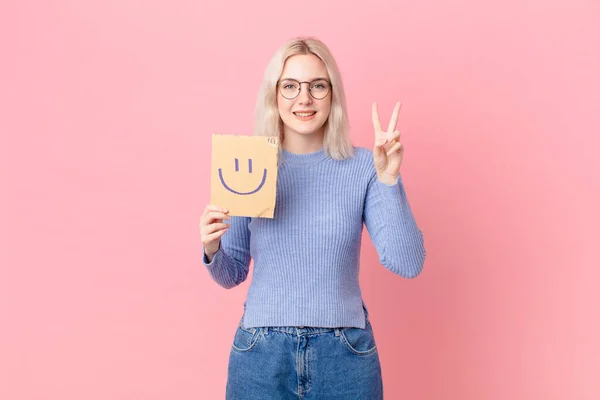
[0,0,600,400]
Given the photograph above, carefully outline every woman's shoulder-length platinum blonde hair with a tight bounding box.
[254,37,353,160]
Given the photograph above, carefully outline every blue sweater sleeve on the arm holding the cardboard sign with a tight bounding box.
[202,216,250,289]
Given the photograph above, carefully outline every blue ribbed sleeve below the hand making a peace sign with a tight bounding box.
[364,173,426,278]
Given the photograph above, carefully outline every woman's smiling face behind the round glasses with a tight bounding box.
[277,54,332,141]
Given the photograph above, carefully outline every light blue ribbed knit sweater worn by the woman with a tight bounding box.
[203,147,426,328]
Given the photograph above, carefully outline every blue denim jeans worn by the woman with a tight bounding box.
[226,305,383,400]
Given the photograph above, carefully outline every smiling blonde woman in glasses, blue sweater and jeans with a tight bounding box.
[200,38,425,400]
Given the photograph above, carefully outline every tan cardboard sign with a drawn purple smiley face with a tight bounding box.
[210,134,278,218]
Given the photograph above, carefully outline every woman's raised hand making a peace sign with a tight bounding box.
[373,102,404,185]
